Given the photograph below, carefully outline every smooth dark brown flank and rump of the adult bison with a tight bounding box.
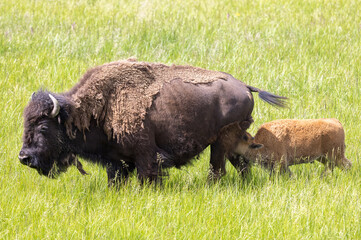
[149,79,253,166]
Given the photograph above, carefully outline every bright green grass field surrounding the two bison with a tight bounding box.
[0,0,361,240]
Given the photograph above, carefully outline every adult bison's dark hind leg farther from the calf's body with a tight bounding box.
[209,140,226,180]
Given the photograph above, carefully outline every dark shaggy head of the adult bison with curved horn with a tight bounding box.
[19,91,77,178]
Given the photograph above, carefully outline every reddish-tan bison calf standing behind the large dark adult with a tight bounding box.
[229,119,351,175]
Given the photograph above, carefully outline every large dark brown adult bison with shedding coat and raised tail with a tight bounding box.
[19,60,285,184]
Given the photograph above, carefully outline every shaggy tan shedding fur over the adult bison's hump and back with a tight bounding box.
[65,59,227,141]
